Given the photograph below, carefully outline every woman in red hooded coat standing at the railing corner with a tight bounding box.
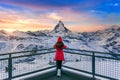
[54,37,66,76]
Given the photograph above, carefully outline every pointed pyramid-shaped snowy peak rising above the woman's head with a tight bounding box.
[52,21,71,33]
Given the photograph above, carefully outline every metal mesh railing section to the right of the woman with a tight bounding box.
[63,49,120,80]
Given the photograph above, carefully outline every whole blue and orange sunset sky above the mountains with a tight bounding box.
[0,0,120,32]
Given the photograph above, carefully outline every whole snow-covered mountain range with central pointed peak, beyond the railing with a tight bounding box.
[0,21,120,53]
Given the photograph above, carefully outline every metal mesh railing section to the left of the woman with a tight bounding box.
[0,49,55,80]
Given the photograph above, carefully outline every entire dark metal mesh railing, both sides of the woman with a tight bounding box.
[0,48,120,80]
